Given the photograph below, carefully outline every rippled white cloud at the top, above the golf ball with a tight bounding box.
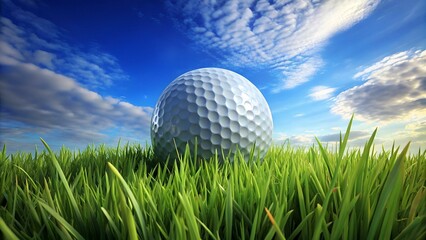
[167,0,379,92]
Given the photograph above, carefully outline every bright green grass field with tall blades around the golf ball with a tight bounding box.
[0,120,426,240]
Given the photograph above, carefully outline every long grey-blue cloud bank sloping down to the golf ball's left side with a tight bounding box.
[0,63,152,149]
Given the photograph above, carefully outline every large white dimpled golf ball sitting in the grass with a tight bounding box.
[151,68,273,161]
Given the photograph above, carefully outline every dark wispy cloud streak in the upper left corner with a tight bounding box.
[0,0,128,90]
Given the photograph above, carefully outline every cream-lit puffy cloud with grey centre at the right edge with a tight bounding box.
[331,50,426,123]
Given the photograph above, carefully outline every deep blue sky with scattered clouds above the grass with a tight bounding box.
[0,0,426,152]
